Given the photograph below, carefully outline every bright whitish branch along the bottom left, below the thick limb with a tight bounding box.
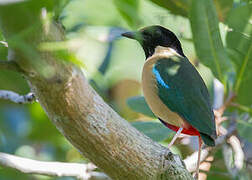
[0,152,110,180]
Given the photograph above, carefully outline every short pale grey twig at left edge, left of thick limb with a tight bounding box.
[0,90,36,104]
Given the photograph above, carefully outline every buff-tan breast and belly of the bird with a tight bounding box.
[142,58,184,127]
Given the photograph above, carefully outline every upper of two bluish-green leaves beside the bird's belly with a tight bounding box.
[127,96,156,118]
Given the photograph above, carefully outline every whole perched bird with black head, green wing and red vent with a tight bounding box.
[122,25,217,178]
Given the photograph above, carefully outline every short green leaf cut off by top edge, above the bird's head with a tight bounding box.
[151,0,191,17]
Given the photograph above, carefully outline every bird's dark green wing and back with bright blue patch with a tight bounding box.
[153,56,216,145]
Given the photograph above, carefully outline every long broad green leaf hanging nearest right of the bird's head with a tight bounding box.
[190,0,232,84]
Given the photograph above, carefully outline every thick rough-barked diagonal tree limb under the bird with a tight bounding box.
[0,0,193,180]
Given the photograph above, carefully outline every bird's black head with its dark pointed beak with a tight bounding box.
[122,25,184,59]
